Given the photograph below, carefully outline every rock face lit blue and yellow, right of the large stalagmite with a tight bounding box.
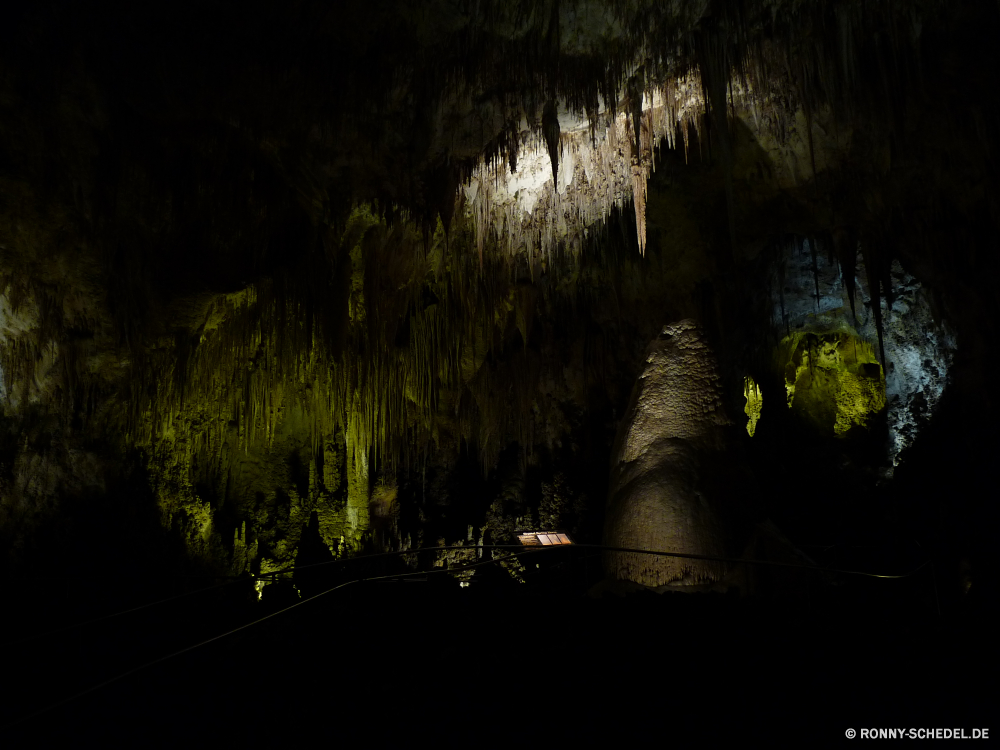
[773,240,957,466]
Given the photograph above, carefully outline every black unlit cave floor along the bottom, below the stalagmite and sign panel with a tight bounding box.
[2,578,995,747]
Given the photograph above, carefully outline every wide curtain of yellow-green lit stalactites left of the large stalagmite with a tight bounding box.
[128,210,552,488]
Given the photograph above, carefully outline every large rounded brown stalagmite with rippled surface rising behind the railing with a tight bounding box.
[605,320,730,586]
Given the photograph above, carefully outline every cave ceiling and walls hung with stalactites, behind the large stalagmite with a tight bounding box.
[0,0,1000,600]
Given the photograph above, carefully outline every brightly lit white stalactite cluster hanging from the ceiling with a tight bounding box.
[459,74,704,267]
